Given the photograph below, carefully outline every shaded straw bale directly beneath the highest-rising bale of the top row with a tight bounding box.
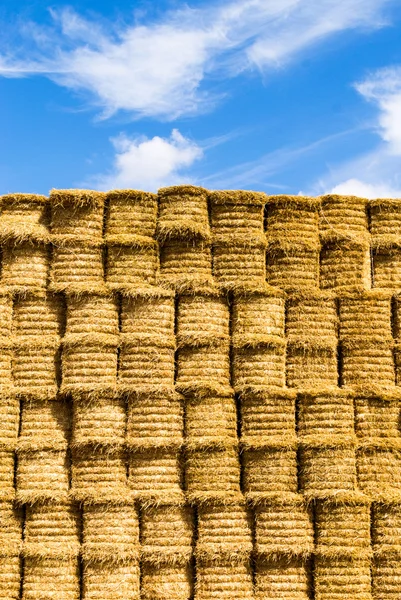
[160,238,213,290]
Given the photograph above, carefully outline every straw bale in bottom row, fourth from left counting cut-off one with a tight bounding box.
[141,563,193,600]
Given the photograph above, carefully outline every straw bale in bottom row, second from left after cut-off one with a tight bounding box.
[22,556,80,600]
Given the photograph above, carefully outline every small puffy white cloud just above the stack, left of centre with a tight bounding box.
[94,129,202,191]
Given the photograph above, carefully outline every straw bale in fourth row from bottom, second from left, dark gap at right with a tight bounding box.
[18,400,71,450]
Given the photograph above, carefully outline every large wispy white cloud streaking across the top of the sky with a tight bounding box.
[0,0,395,119]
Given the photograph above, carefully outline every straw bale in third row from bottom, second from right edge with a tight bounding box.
[299,446,356,498]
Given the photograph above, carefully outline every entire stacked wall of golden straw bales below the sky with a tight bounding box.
[0,185,401,600]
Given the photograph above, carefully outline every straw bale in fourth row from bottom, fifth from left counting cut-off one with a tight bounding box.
[185,395,237,448]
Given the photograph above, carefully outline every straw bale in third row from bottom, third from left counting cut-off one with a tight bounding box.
[71,447,129,503]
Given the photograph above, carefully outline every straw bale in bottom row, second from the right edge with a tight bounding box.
[314,556,372,600]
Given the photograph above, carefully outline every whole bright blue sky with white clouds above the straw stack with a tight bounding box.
[0,0,401,197]
